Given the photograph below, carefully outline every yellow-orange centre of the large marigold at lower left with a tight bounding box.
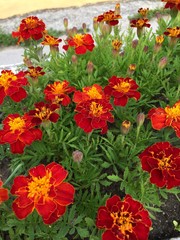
[28,172,52,202]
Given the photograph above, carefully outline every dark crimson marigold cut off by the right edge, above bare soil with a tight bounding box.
[139,142,180,189]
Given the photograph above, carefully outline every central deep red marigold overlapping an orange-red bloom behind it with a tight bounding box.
[74,99,114,134]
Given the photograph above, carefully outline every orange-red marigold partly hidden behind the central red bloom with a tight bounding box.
[73,84,105,103]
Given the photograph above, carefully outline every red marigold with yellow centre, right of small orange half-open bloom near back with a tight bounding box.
[63,33,94,54]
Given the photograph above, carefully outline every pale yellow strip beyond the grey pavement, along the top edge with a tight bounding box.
[0,0,113,19]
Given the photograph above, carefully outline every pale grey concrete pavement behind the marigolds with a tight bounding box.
[0,0,169,67]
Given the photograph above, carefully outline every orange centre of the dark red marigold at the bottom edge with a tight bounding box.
[111,211,134,235]
